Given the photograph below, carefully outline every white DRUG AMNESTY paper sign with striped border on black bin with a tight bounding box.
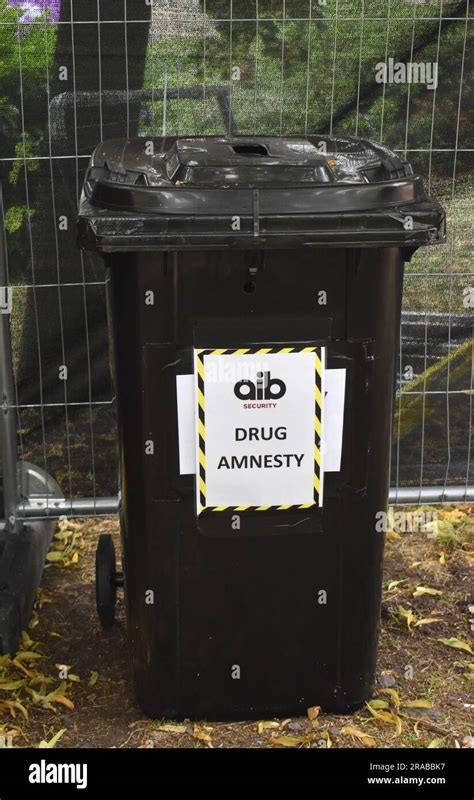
[195,347,325,513]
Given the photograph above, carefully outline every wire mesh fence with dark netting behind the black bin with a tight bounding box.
[0,0,474,520]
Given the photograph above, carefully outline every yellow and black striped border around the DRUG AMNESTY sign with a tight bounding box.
[195,346,324,514]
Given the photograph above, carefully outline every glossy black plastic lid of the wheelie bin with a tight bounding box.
[78,136,445,252]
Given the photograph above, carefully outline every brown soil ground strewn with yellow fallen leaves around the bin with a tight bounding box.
[0,506,474,748]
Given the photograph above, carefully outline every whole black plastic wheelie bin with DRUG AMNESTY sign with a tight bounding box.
[78,136,445,719]
